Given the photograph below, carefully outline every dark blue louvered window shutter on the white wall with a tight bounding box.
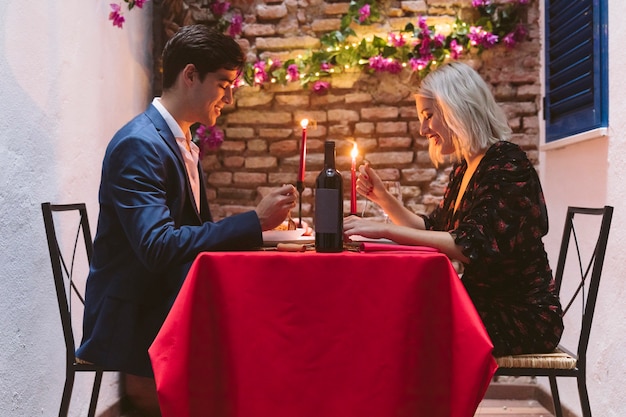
[544,0,608,142]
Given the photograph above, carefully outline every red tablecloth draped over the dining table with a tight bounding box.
[150,252,496,417]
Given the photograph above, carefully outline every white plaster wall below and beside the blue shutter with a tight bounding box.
[541,0,626,417]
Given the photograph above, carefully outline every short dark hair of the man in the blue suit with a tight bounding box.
[163,25,245,90]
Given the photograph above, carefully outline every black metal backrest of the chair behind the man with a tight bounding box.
[41,203,93,363]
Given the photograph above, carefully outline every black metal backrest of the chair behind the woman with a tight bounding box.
[554,206,613,366]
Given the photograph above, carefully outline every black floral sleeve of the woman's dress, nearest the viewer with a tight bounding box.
[450,150,548,264]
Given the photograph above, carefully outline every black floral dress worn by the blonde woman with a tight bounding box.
[424,141,563,356]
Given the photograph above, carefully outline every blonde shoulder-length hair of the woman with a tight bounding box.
[415,62,511,165]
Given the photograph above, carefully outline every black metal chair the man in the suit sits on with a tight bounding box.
[41,203,114,417]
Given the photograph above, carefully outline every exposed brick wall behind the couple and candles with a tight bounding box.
[154,0,541,223]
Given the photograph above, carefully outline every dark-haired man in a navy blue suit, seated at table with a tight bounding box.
[76,25,296,415]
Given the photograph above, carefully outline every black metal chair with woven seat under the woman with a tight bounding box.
[496,206,613,417]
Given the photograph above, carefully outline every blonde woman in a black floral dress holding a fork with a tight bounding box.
[344,62,563,356]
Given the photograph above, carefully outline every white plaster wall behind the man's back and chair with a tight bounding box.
[0,0,152,417]
